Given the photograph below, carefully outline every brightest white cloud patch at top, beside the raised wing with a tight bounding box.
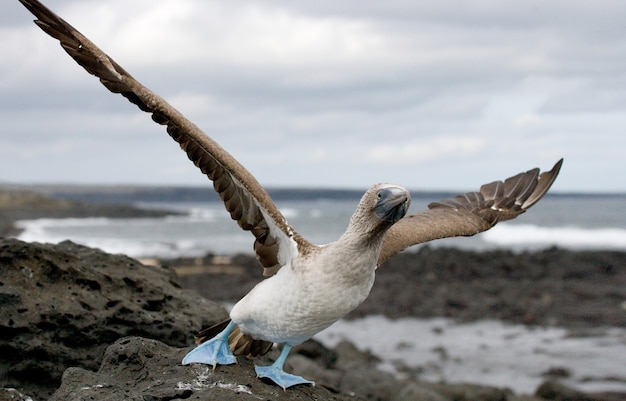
[59,0,384,78]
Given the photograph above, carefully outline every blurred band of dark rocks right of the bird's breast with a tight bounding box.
[364,247,626,328]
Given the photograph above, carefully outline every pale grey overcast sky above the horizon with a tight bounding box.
[0,0,626,192]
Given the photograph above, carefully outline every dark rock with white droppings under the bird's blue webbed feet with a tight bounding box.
[50,337,358,401]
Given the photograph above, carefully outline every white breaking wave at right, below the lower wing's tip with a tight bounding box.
[482,224,626,250]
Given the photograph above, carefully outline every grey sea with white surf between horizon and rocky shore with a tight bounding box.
[18,193,626,258]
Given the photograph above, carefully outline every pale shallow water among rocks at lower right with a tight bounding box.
[315,316,626,394]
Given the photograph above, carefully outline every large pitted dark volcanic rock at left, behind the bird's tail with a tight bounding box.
[0,238,227,398]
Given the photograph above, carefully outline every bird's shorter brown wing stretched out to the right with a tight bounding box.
[378,159,563,266]
